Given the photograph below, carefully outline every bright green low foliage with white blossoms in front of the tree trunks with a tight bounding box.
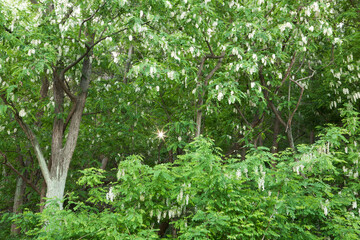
[16,122,360,239]
